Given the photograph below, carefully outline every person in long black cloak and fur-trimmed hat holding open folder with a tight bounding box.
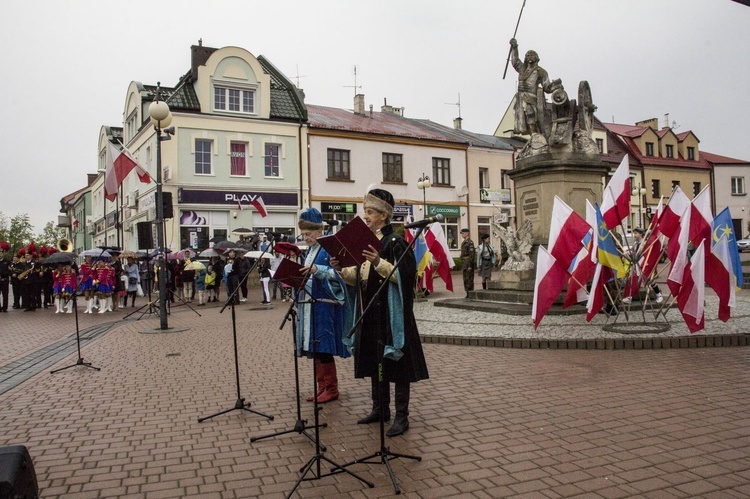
[331,189,429,437]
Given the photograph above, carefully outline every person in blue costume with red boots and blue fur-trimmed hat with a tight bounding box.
[297,208,350,404]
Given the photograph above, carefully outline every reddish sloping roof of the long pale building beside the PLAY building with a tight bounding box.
[307,104,463,144]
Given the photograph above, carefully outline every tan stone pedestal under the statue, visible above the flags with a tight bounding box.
[508,152,610,246]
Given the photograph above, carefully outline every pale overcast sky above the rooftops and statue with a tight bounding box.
[0,0,750,231]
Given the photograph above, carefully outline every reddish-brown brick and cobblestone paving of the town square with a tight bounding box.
[0,281,750,498]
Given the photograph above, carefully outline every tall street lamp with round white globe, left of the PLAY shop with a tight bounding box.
[148,82,174,329]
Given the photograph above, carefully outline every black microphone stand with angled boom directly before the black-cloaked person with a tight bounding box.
[333,226,424,494]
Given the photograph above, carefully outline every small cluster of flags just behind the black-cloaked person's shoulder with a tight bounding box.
[404,216,455,293]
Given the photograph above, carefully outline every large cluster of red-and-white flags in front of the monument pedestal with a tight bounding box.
[532,156,743,332]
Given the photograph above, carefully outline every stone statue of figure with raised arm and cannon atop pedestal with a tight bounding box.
[510,38,598,159]
